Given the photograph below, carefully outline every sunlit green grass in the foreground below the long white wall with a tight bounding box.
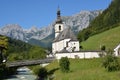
[47,59,120,80]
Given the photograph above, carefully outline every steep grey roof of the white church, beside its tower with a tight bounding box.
[53,28,78,42]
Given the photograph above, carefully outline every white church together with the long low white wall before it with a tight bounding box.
[52,8,101,60]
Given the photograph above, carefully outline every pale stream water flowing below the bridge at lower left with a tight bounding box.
[5,67,36,80]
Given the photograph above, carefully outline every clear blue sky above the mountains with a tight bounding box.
[0,0,112,29]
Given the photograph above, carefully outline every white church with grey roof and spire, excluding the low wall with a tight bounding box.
[52,8,79,54]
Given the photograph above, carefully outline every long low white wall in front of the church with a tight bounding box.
[55,52,100,59]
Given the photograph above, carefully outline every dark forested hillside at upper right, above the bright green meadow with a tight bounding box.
[78,0,120,42]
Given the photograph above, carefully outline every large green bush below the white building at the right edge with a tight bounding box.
[103,52,120,71]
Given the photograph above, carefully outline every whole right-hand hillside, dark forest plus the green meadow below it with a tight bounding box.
[78,0,120,50]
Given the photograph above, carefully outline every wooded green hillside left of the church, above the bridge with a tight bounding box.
[0,35,46,61]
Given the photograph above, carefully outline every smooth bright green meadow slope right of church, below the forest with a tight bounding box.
[81,26,120,50]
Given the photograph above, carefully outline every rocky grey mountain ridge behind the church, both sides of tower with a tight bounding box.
[0,10,102,47]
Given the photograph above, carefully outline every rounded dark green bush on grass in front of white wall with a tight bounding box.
[59,57,70,72]
